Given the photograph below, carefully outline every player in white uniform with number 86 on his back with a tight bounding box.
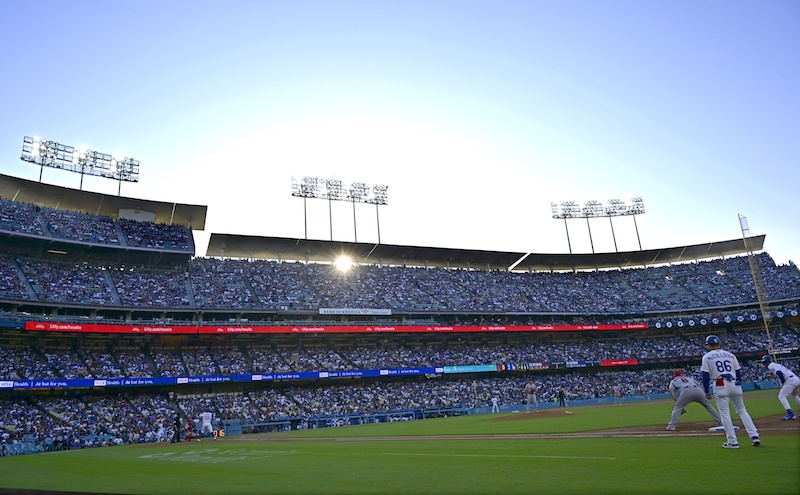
[700,335,761,449]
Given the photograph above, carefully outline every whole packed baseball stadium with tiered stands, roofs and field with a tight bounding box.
[0,171,800,494]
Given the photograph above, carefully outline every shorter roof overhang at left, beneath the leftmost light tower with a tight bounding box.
[0,174,208,230]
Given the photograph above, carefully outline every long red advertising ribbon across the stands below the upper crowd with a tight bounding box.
[25,321,647,338]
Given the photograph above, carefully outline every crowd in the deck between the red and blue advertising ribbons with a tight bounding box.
[0,327,800,380]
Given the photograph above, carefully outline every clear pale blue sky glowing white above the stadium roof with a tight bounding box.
[0,0,800,264]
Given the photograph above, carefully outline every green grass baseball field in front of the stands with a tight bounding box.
[0,391,800,495]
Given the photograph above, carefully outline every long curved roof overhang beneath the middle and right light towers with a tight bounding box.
[206,234,765,271]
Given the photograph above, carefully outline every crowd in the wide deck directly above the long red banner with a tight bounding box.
[0,253,800,318]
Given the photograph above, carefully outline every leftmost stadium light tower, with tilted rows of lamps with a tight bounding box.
[20,136,139,196]
